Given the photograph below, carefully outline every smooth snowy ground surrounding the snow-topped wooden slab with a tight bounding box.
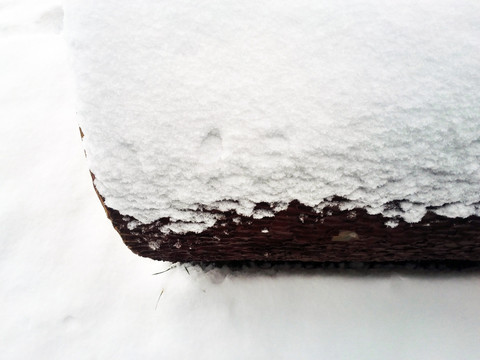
[0,0,480,360]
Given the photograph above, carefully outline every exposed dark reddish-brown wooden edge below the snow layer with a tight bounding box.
[92,174,480,262]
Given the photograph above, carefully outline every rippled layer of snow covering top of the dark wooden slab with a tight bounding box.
[65,0,480,230]
